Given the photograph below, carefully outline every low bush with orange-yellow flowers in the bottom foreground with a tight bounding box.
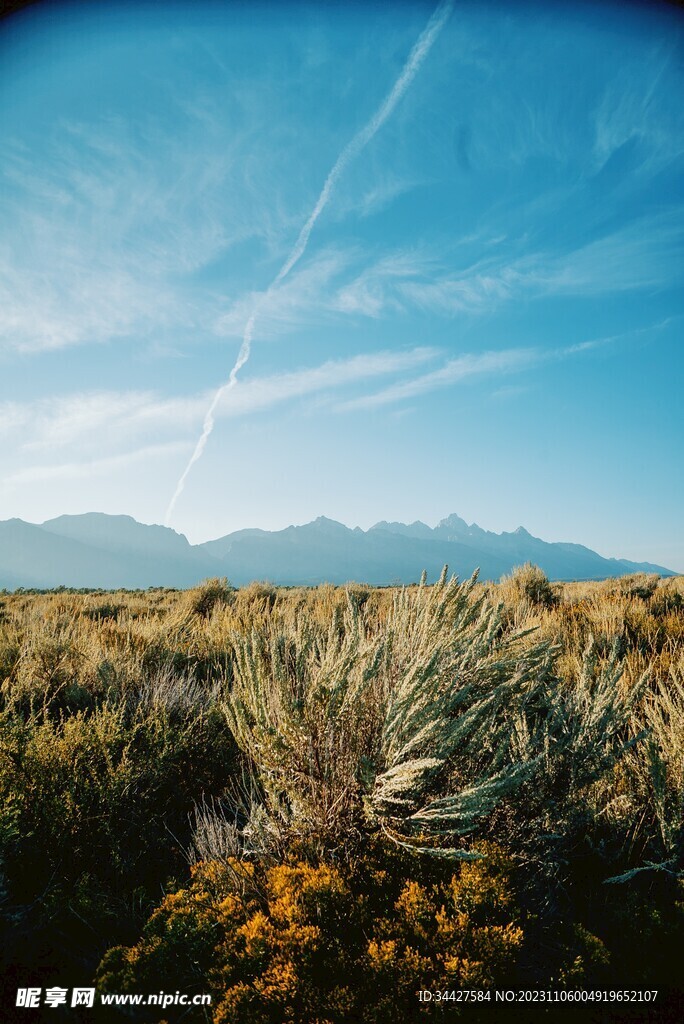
[97,844,523,1024]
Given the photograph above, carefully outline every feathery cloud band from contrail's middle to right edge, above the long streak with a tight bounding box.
[218,214,684,338]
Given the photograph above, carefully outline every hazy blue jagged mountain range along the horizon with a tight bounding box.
[0,512,675,590]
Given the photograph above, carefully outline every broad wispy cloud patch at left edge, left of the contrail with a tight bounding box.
[0,106,282,352]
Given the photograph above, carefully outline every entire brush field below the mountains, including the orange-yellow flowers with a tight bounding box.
[0,566,684,1024]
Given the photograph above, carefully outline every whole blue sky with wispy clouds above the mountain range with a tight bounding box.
[0,2,684,571]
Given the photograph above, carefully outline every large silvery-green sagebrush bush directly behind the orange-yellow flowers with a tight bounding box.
[224,571,552,855]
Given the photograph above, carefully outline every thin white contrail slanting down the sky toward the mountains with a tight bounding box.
[164,0,454,526]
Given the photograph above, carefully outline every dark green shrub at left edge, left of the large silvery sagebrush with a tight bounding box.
[0,700,234,917]
